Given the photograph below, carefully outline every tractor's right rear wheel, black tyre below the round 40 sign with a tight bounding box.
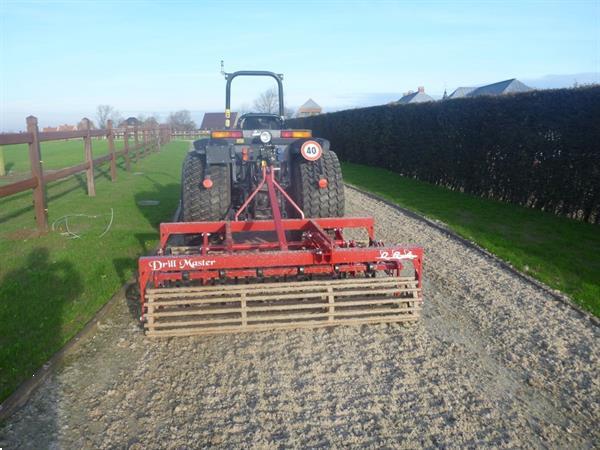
[290,150,344,217]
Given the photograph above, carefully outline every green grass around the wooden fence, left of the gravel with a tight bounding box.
[0,141,189,400]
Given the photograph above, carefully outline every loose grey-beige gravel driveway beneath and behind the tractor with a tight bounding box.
[0,188,600,449]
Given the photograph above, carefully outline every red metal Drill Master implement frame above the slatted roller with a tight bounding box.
[139,217,423,317]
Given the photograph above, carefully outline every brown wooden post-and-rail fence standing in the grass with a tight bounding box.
[0,116,171,233]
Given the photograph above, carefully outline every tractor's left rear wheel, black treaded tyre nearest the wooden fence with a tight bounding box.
[181,152,231,222]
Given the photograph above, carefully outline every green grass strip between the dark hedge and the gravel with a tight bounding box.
[342,163,600,316]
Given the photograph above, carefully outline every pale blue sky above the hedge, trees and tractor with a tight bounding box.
[0,0,600,131]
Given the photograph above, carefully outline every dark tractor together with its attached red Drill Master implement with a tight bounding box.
[139,71,423,336]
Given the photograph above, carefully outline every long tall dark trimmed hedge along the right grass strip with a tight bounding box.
[288,86,600,223]
